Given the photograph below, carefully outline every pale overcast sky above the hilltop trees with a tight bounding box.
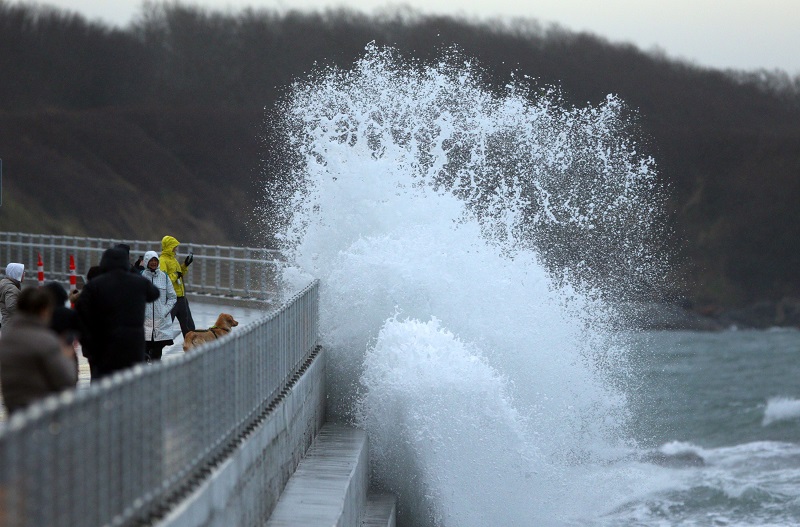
[18,0,800,76]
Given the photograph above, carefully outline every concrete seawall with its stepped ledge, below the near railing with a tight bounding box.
[158,342,396,527]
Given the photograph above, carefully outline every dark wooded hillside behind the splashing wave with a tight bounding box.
[0,0,800,306]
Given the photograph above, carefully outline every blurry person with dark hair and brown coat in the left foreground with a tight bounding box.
[0,287,78,414]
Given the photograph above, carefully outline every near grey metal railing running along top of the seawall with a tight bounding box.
[0,235,319,527]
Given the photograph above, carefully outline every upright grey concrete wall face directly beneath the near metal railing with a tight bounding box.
[158,349,326,527]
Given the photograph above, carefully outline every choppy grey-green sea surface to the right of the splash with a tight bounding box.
[594,329,800,526]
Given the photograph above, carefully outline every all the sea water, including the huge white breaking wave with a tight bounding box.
[264,46,800,527]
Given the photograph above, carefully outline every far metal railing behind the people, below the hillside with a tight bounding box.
[0,232,284,300]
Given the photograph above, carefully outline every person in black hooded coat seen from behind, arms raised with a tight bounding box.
[75,248,159,382]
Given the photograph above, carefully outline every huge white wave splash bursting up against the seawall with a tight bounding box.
[274,47,668,526]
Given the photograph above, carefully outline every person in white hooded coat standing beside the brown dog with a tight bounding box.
[142,251,178,362]
